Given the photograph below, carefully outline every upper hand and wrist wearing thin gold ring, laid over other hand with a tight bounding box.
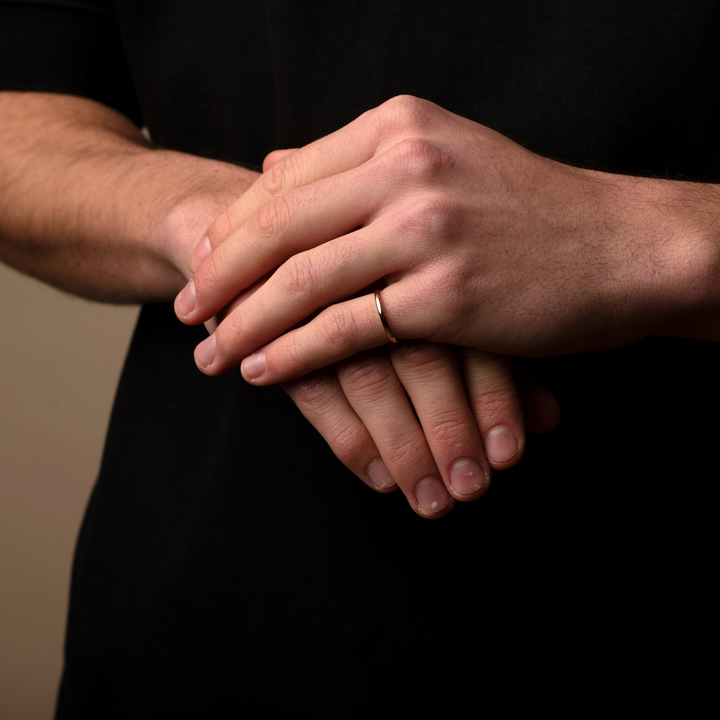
[176,97,718,385]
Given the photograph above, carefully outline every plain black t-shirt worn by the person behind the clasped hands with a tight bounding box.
[0,0,720,718]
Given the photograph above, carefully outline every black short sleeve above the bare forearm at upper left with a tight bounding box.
[0,0,143,125]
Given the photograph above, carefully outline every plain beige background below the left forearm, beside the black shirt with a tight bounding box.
[0,265,137,720]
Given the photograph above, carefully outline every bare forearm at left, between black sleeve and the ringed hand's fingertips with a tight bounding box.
[0,93,257,302]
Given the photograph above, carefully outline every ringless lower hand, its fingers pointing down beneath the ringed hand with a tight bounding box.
[190,151,559,518]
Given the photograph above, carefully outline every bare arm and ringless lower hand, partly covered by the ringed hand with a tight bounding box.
[0,92,558,518]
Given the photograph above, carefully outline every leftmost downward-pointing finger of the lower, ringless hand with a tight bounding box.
[282,368,397,493]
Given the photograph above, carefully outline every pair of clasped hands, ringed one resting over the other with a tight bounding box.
[175,97,664,517]
